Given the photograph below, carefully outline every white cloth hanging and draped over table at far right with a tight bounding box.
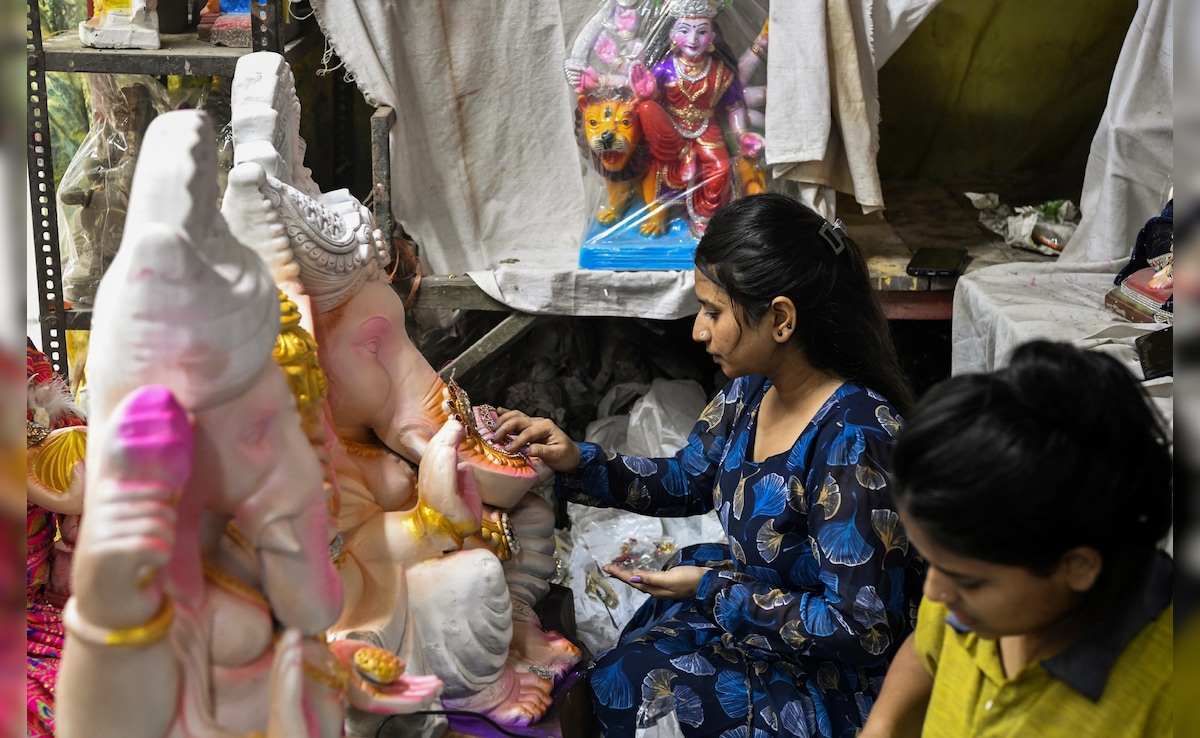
[952,0,1174,393]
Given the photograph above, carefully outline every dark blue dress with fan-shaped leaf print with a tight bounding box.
[556,376,923,738]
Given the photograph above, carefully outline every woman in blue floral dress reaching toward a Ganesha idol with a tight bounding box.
[498,194,922,738]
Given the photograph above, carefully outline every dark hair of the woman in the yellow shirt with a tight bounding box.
[893,341,1172,613]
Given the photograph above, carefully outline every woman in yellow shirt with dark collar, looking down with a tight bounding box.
[860,342,1172,738]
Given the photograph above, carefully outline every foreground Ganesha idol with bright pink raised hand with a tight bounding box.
[56,112,440,738]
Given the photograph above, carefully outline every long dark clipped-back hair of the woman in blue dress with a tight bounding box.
[696,193,913,413]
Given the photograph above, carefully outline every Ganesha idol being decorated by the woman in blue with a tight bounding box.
[222,52,580,734]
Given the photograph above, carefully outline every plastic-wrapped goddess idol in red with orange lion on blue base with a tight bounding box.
[564,0,768,269]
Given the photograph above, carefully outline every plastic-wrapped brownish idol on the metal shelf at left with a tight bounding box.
[58,74,170,306]
